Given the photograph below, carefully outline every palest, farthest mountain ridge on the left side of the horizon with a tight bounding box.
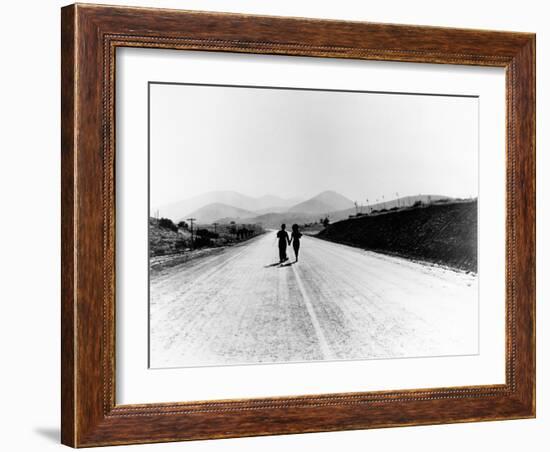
[154,191,303,221]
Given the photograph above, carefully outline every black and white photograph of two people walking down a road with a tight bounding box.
[149,81,479,369]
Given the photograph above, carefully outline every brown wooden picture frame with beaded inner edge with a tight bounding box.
[61,4,535,447]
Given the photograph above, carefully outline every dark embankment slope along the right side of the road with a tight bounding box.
[317,201,477,272]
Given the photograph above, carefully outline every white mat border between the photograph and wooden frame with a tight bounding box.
[116,48,506,404]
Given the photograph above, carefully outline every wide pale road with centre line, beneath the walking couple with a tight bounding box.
[150,232,478,368]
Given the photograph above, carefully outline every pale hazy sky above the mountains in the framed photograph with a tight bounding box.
[150,84,478,208]
